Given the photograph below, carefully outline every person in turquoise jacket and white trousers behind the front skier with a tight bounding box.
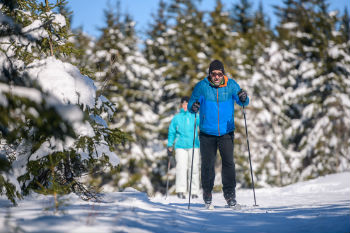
[168,96,199,199]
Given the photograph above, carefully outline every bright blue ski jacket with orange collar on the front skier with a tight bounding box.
[188,76,249,136]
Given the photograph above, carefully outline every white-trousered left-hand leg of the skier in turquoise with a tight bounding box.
[175,149,187,196]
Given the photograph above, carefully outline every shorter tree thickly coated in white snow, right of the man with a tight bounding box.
[247,41,296,185]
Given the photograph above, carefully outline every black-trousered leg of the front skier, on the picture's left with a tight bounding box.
[199,133,217,202]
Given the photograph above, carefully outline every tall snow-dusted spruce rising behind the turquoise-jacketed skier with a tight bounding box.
[146,0,208,155]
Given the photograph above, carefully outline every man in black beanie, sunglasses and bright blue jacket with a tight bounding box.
[188,60,249,207]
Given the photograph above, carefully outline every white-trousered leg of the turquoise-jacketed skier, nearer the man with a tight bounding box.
[187,148,199,196]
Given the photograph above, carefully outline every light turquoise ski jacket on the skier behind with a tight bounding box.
[168,108,199,149]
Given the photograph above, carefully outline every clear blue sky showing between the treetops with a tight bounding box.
[66,0,350,37]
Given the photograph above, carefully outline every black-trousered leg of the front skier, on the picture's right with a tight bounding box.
[218,132,236,200]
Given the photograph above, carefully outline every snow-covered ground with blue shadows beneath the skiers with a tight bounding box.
[0,172,350,233]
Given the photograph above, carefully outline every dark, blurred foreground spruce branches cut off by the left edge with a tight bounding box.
[0,1,76,203]
